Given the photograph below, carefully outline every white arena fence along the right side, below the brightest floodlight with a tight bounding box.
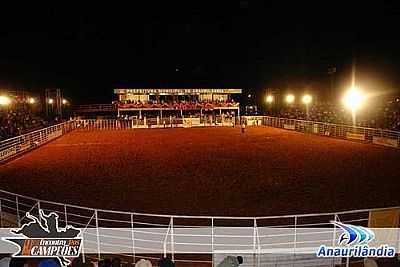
[244,116,400,148]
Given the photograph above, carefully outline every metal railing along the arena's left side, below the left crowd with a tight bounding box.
[0,121,76,163]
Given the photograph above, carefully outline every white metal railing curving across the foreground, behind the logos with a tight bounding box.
[0,190,400,266]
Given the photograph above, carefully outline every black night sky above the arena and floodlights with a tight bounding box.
[0,0,400,103]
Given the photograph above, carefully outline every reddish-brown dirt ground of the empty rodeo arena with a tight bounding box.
[0,127,400,216]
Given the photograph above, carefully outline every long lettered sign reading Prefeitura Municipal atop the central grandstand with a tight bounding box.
[114,88,242,95]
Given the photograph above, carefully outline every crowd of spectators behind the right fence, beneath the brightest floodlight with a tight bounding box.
[270,98,400,131]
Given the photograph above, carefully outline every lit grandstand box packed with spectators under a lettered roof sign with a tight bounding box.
[114,88,242,117]
